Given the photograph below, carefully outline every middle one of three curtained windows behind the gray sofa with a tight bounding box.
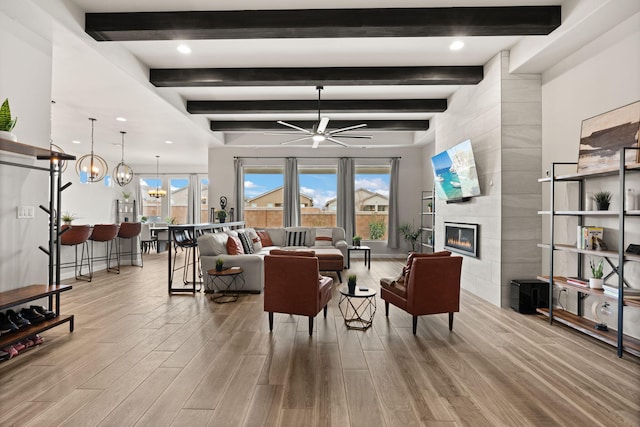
[298,166,338,227]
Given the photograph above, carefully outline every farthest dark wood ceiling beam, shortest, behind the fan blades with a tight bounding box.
[209,120,429,135]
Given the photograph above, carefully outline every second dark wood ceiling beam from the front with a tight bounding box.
[149,65,484,87]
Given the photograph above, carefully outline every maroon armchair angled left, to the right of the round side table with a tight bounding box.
[380,252,462,335]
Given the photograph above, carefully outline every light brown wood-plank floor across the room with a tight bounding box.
[0,254,640,427]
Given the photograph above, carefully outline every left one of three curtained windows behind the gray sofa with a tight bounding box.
[244,166,284,227]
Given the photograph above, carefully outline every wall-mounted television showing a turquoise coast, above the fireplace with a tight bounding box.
[431,139,480,202]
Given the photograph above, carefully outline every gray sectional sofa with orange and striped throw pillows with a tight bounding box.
[198,227,348,292]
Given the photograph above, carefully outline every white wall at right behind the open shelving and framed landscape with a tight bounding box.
[541,14,640,336]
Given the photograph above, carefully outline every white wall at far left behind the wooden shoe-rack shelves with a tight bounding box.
[0,2,51,291]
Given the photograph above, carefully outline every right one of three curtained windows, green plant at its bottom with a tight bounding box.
[354,165,391,240]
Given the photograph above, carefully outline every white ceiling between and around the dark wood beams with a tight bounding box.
[34,0,640,171]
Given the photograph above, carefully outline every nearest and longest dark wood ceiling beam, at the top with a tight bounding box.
[85,6,561,41]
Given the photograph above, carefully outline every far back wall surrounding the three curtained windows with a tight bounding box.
[209,145,430,255]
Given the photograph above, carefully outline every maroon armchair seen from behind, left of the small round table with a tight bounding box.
[264,251,333,336]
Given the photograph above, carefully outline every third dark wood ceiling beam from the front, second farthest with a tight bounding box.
[187,99,447,114]
